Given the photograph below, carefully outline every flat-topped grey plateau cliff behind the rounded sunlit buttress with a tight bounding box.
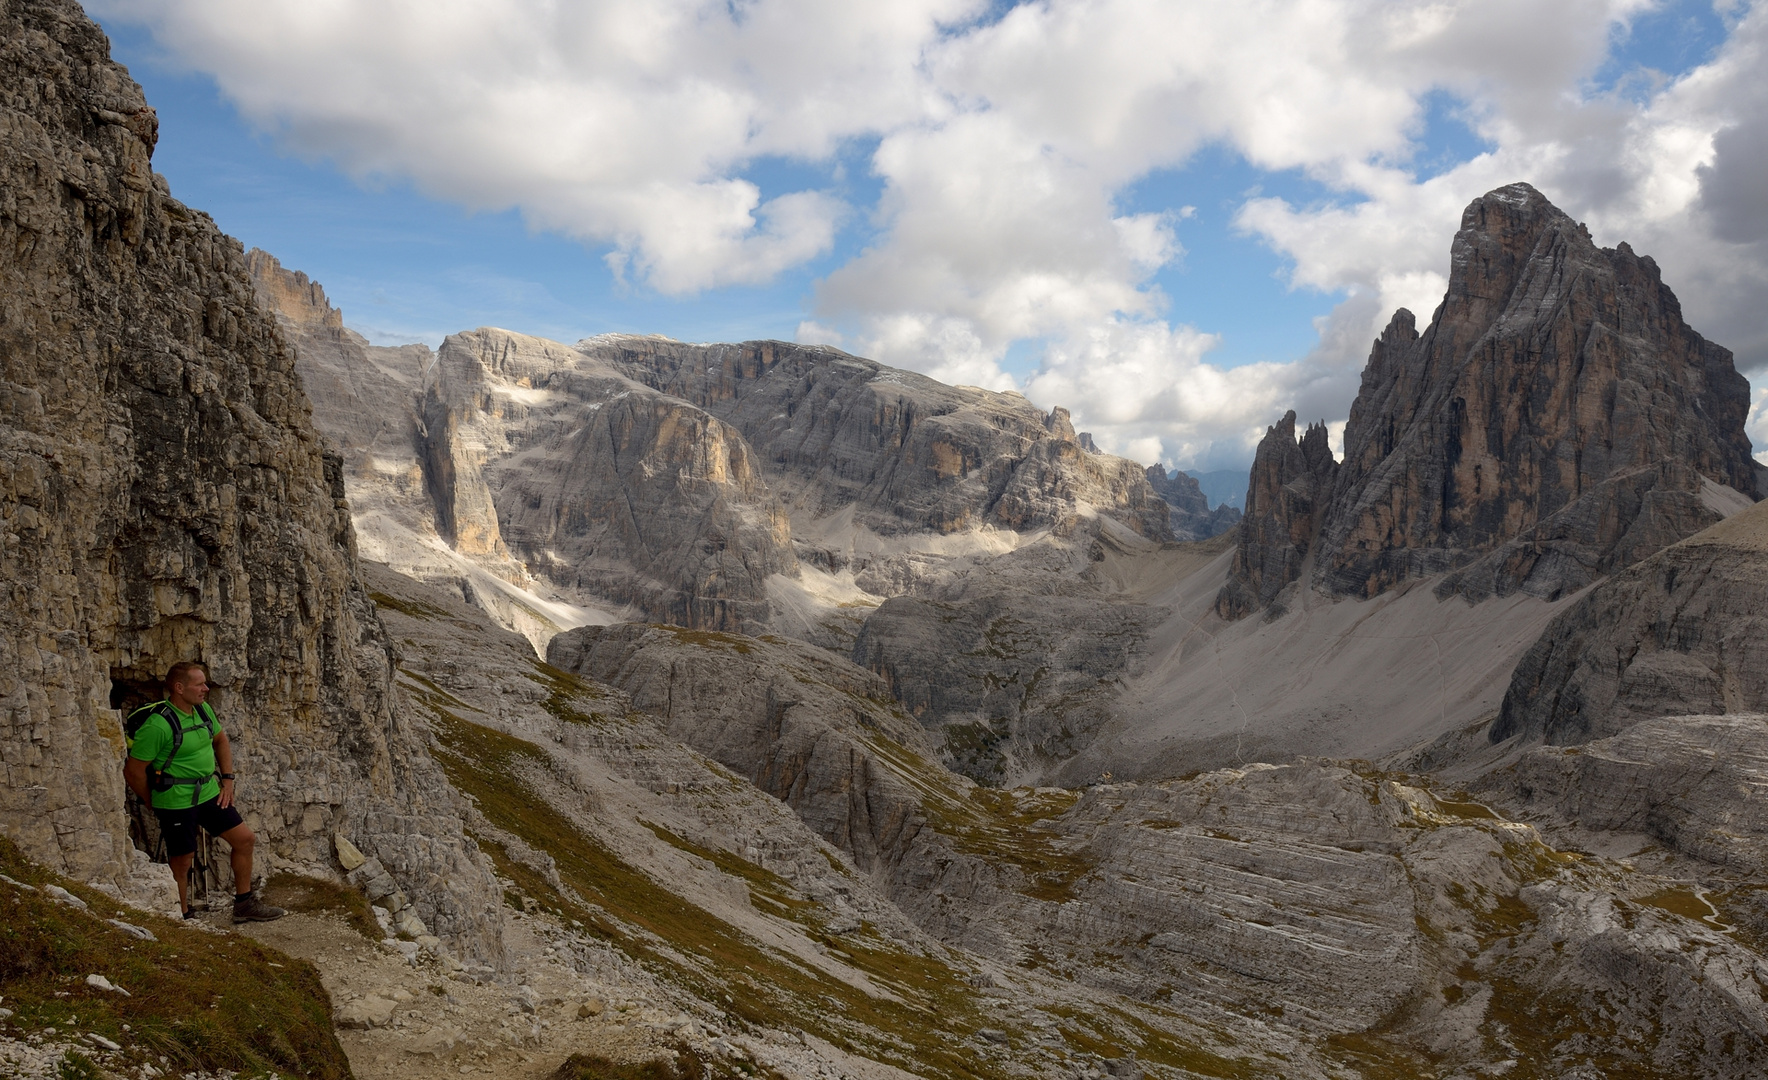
[580,336,1172,539]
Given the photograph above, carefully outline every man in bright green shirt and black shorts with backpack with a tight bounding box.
[122,661,288,923]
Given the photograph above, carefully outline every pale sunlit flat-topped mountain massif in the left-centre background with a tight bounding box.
[253,245,1174,649]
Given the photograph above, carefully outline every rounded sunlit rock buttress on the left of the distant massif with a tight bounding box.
[423,329,797,629]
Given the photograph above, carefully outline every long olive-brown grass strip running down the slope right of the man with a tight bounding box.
[422,711,1001,1078]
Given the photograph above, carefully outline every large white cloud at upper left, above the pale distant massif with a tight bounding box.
[94,0,976,293]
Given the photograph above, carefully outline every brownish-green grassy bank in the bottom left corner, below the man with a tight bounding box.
[0,836,350,1080]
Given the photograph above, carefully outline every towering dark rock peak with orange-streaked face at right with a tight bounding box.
[1225,184,1759,612]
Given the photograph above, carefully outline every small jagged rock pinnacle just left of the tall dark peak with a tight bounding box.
[1216,410,1338,619]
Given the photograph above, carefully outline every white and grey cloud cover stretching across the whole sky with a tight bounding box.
[95,0,1768,465]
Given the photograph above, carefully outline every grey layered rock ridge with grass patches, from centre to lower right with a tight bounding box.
[550,622,1768,1075]
